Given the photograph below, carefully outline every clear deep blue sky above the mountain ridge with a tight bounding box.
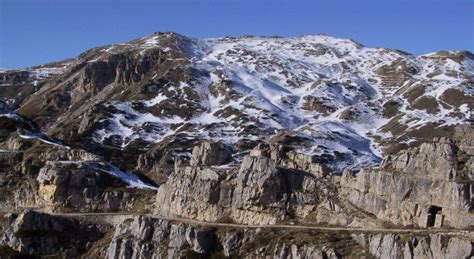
[0,0,474,68]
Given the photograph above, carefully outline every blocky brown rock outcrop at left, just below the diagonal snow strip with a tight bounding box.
[36,161,153,212]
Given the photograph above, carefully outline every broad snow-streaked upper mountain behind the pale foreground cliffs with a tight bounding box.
[0,33,474,175]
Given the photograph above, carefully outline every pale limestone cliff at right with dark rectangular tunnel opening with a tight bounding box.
[340,139,474,228]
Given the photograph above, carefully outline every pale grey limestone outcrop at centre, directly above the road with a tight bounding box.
[156,143,329,224]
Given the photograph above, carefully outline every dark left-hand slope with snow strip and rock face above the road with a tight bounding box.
[0,103,156,215]
